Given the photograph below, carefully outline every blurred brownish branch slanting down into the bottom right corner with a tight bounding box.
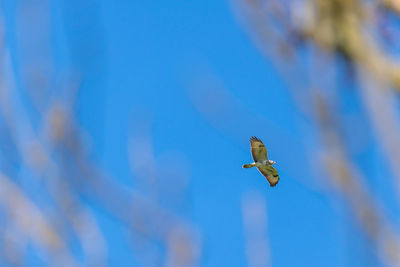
[315,94,400,266]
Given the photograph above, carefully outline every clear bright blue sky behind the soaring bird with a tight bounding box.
[3,0,390,267]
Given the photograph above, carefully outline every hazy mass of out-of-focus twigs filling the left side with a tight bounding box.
[0,1,201,266]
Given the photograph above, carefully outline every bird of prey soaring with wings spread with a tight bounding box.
[243,136,279,187]
